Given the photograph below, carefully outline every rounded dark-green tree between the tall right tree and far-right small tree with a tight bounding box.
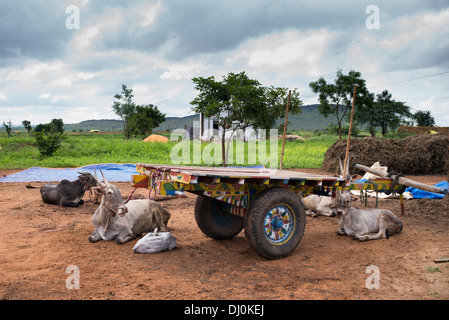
[354,90,413,135]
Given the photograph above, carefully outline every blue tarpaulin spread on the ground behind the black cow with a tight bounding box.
[0,163,137,182]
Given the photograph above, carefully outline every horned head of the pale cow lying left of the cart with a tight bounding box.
[92,170,128,218]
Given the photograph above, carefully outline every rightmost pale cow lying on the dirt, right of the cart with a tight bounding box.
[337,190,403,241]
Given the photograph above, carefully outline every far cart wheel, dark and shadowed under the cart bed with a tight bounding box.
[195,196,243,240]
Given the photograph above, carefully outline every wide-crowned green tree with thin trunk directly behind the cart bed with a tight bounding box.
[190,72,301,166]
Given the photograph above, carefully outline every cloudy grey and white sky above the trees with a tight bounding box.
[0,0,449,126]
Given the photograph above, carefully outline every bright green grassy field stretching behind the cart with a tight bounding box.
[0,133,337,169]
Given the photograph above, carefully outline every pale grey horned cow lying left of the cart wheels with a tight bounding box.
[89,172,170,244]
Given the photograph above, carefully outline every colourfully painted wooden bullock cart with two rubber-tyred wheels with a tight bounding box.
[132,163,438,259]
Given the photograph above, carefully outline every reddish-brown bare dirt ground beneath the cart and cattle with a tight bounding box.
[0,170,449,300]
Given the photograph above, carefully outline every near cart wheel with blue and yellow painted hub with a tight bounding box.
[244,188,306,259]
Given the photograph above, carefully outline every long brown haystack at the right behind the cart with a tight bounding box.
[321,134,449,175]
